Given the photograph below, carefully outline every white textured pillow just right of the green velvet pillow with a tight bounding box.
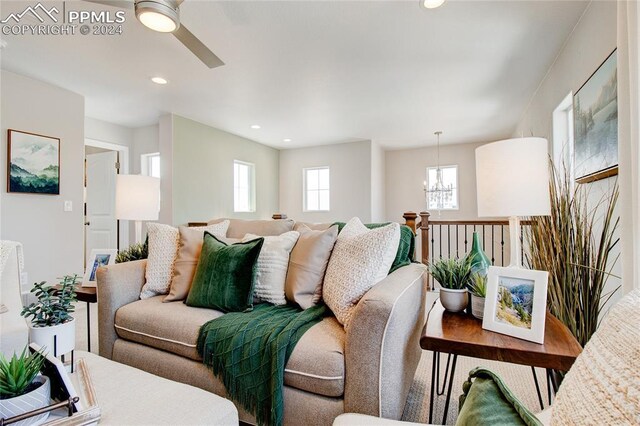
[242,231,300,305]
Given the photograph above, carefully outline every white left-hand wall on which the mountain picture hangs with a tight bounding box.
[0,70,84,284]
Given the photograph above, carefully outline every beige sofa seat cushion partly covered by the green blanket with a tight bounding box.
[115,296,346,397]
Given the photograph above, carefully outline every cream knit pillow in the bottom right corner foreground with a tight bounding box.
[551,289,640,426]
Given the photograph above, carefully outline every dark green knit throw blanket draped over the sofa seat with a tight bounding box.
[198,303,328,426]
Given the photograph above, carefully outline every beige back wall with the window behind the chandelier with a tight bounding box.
[386,143,482,221]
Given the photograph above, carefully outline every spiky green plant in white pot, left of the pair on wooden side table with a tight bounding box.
[429,256,472,312]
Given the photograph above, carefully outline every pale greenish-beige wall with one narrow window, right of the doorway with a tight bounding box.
[169,115,278,224]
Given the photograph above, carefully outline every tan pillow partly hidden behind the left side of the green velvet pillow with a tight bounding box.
[162,220,229,302]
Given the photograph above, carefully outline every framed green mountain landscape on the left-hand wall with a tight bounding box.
[7,129,60,195]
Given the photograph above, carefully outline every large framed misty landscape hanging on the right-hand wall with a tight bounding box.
[573,50,618,183]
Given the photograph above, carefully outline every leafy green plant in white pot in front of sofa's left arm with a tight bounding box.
[20,275,78,356]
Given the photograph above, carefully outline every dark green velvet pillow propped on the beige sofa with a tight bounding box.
[185,231,264,312]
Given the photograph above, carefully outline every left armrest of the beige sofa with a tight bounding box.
[97,260,147,359]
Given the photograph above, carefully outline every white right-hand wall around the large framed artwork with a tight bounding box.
[514,2,624,302]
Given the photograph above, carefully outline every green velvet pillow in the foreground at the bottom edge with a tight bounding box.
[456,367,542,426]
